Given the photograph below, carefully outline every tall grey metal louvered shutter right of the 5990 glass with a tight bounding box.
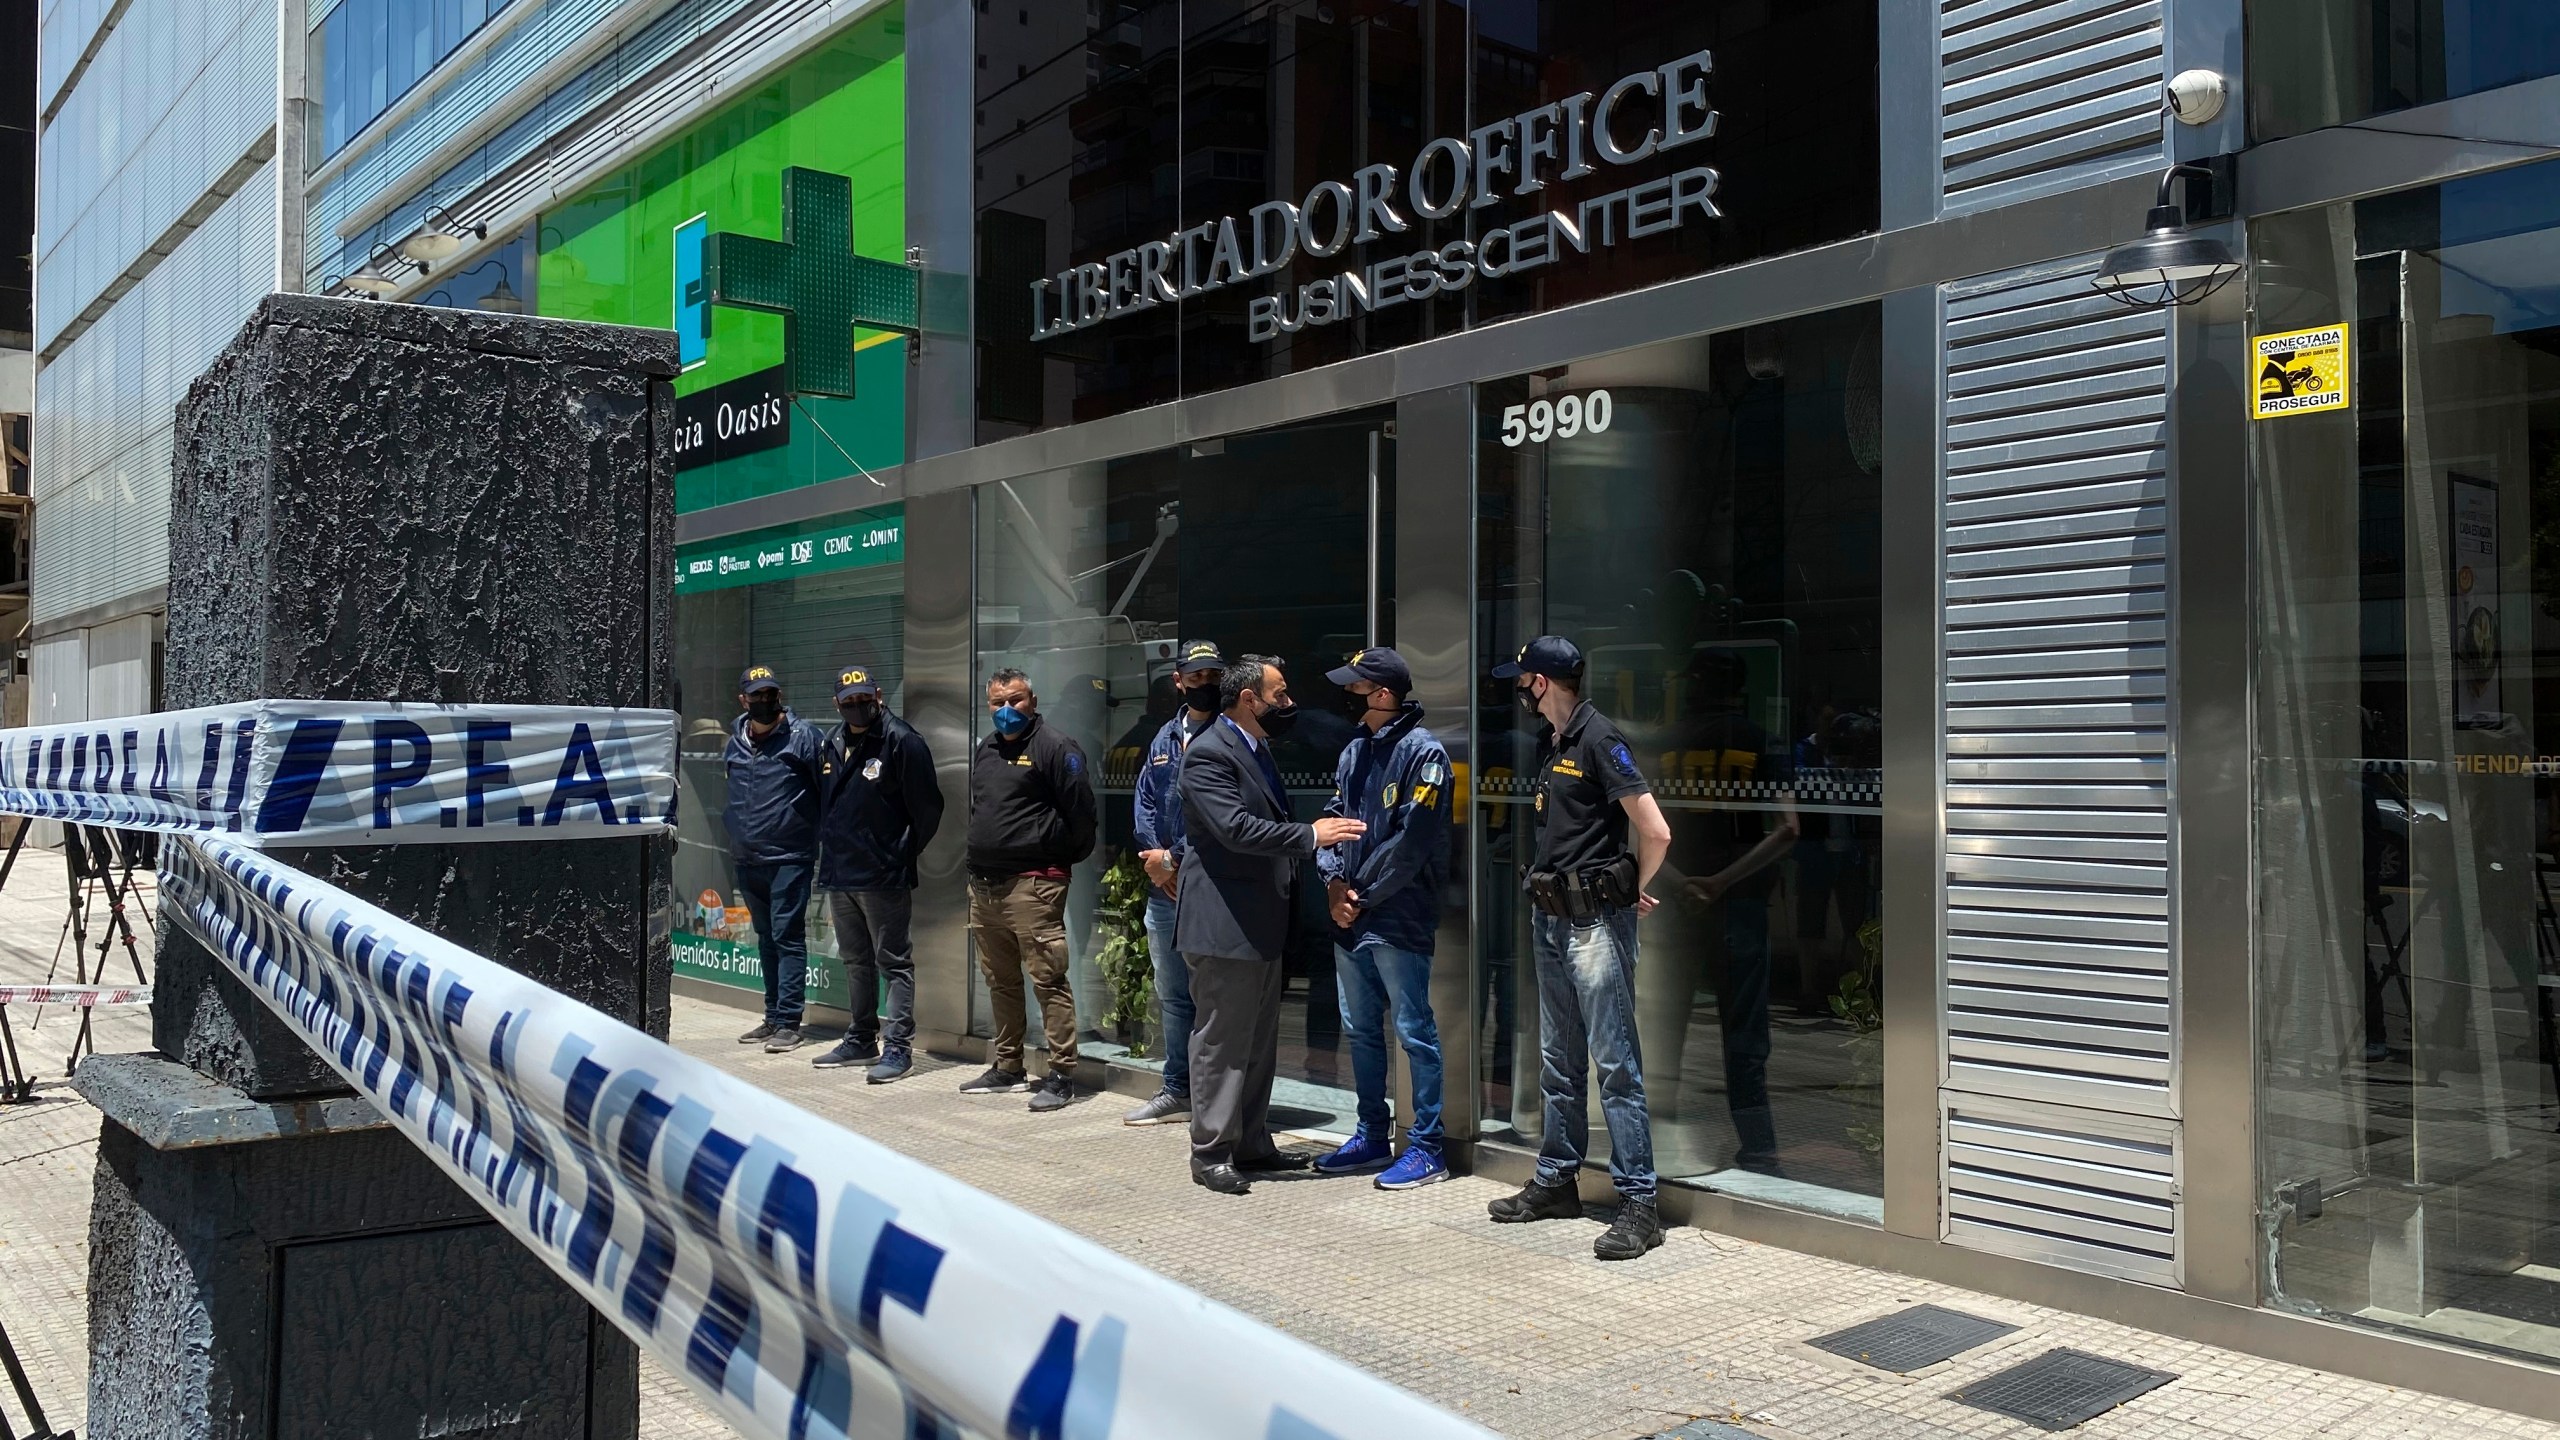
[1940,259,2176,1281]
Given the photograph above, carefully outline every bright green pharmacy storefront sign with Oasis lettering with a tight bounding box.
[535,5,914,509]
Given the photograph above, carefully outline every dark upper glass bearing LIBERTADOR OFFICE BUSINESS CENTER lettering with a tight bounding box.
[975,0,1879,441]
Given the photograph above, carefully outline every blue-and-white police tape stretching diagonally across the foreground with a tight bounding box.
[164,838,1487,1440]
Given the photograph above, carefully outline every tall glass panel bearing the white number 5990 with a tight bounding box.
[1475,305,1884,1220]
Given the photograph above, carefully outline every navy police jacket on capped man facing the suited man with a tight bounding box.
[1316,702,1449,956]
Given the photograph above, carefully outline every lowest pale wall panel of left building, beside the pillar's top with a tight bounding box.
[31,164,276,625]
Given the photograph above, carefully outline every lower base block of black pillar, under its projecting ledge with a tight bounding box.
[90,1091,640,1440]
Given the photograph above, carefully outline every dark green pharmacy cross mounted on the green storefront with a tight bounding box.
[701,167,919,400]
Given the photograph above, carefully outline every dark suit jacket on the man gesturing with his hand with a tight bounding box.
[1172,717,1316,963]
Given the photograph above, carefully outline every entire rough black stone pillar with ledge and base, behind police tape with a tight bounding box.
[79,295,676,1440]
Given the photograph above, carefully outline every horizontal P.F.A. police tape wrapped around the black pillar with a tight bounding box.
[0,700,676,846]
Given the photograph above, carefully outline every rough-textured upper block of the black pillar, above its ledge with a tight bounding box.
[151,295,676,1099]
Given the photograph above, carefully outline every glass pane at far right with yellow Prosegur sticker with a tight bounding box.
[2250,164,2560,1361]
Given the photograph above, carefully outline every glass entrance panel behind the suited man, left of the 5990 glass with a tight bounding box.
[955,413,1395,1127]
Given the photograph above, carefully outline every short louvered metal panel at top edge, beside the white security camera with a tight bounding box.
[1938,0,2166,210]
